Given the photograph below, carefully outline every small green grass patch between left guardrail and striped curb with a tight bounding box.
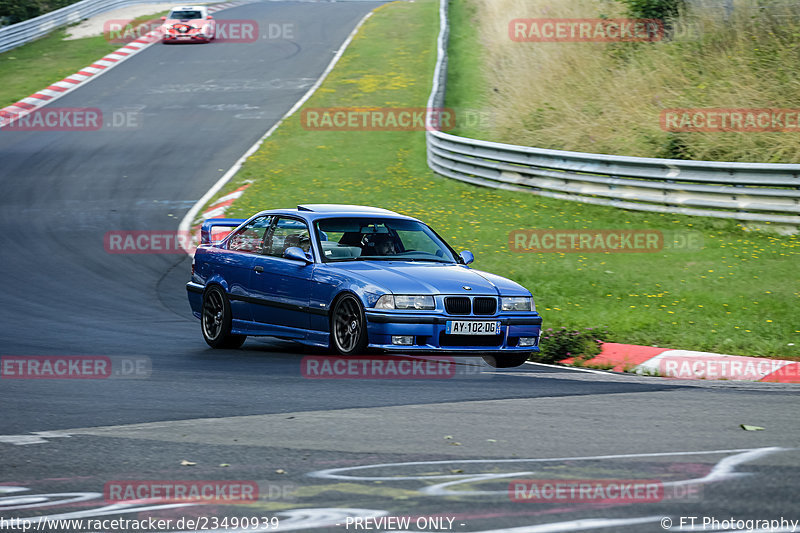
[0,11,166,107]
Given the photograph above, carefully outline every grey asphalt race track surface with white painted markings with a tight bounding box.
[0,2,800,533]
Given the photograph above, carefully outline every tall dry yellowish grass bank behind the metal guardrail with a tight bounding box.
[450,0,800,164]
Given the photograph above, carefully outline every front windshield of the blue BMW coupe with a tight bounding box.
[316,217,456,263]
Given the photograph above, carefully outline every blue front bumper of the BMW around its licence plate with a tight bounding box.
[366,310,542,355]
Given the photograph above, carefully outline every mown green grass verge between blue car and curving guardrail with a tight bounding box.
[202,0,800,357]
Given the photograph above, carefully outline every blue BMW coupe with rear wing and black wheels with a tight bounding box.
[186,205,542,367]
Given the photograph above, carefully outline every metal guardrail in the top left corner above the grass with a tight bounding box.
[0,0,170,53]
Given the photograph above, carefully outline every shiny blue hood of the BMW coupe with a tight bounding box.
[331,261,530,296]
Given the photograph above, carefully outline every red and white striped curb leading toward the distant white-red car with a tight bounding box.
[0,0,253,128]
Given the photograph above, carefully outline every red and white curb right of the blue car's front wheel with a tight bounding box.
[565,342,800,383]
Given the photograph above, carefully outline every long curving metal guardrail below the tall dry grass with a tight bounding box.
[427,0,800,226]
